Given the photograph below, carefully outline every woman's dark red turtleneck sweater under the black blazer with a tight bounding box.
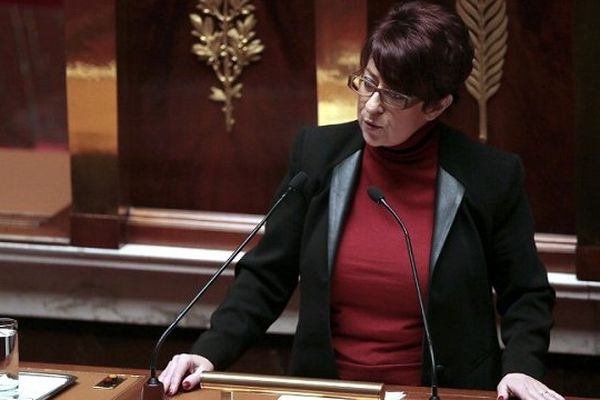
[331,123,438,385]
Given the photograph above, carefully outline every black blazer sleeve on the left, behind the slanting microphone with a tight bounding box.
[192,128,309,369]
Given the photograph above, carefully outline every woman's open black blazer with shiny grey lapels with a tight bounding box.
[192,121,554,389]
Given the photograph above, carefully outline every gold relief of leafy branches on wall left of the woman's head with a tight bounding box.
[190,0,264,132]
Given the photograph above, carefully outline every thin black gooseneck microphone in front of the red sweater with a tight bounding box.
[367,186,440,400]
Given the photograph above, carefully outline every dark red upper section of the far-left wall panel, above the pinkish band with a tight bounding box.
[0,0,68,150]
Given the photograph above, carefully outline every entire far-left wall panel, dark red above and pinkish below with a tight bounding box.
[0,0,71,243]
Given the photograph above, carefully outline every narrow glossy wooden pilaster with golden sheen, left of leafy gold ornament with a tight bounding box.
[63,0,121,248]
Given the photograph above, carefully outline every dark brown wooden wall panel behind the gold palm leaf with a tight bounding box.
[448,0,575,234]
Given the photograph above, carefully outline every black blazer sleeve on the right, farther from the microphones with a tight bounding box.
[491,158,555,379]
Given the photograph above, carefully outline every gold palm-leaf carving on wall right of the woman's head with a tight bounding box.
[456,0,508,142]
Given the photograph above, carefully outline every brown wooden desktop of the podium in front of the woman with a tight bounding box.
[21,362,584,400]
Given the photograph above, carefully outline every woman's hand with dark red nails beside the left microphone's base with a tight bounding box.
[158,354,215,396]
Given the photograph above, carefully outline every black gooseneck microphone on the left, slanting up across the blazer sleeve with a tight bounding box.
[141,171,308,400]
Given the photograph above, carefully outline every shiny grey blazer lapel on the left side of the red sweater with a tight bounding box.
[327,149,362,274]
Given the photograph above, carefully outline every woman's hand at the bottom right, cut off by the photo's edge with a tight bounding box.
[497,373,565,400]
